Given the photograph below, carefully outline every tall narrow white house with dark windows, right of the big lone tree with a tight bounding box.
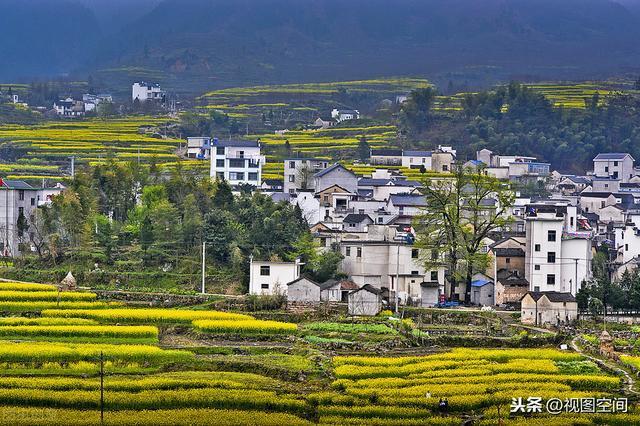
[525,201,592,295]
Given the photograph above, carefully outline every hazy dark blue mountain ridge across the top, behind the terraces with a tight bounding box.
[0,0,640,91]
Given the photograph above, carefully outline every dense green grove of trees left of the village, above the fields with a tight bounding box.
[17,159,340,292]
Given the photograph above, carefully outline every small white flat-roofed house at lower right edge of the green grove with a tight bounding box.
[249,259,302,295]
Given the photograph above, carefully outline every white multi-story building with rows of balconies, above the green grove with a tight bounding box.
[210,139,265,186]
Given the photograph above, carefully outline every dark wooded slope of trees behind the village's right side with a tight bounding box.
[399,83,640,173]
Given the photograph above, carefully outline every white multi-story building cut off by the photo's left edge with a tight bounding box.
[0,179,64,256]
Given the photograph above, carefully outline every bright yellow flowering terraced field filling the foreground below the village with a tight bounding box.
[0,283,640,425]
